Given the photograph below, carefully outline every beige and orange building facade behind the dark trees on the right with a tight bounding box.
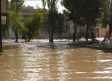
[58,21,112,38]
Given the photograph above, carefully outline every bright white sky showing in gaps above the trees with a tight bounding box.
[24,0,64,13]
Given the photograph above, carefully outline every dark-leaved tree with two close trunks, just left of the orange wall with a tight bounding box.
[83,0,106,40]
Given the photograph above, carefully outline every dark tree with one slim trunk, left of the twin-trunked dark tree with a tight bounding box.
[62,0,83,41]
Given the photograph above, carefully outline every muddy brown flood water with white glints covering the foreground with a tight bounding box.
[0,41,112,81]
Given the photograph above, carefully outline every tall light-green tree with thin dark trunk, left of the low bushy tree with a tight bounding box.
[8,0,24,42]
